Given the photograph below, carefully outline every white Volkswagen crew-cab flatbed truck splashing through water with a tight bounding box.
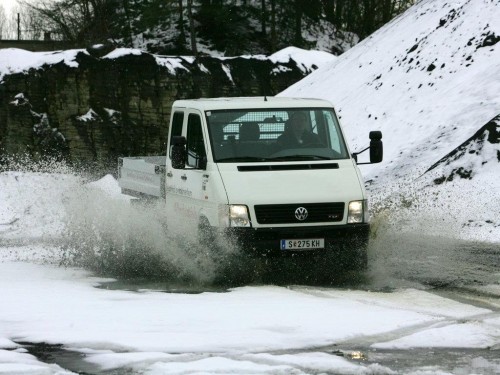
[118,97,383,269]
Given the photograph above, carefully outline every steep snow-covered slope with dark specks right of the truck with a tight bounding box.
[280,0,500,241]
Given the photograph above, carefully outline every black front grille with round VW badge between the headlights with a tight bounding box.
[254,202,345,224]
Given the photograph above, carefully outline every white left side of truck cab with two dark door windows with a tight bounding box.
[165,110,207,233]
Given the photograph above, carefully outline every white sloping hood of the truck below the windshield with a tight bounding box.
[218,160,364,206]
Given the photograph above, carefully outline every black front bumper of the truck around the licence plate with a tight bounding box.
[225,223,370,256]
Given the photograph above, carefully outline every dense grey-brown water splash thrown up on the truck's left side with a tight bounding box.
[61,185,258,284]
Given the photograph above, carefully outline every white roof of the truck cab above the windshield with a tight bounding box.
[173,96,333,111]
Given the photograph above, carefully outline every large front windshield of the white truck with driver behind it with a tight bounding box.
[206,108,349,163]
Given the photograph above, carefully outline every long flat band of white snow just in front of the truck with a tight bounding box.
[0,262,460,353]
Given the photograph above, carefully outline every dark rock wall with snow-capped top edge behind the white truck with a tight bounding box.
[0,51,308,173]
